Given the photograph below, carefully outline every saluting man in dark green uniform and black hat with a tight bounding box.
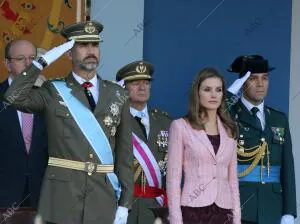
[228,55,297,224]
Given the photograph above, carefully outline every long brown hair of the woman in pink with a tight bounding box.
[185,67,237,137]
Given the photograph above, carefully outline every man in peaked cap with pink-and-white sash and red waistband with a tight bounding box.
[116,61,171,224]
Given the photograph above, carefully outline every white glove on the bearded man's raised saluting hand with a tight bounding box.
[33,40,75,70]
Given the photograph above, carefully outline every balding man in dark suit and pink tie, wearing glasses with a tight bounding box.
[0,40,48,208]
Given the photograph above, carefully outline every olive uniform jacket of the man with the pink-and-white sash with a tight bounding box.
[127,109,171,224]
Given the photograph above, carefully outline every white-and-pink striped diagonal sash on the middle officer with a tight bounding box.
[132,133,164,206]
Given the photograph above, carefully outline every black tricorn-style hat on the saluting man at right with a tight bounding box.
[227,55,275,77]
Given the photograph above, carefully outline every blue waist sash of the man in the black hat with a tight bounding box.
[238,165,280,183]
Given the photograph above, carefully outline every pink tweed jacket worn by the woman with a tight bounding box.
[167,117,241,224]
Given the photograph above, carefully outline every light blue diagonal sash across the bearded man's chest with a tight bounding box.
[52,81,121,200]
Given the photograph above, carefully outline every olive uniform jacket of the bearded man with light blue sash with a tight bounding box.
[5,65,133,224]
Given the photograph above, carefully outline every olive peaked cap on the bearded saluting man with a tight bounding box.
[61,21,103,42]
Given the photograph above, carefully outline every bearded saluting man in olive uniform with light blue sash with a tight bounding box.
[6,21,133,224]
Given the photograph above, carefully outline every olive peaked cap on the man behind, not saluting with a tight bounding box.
[116,61,154,82]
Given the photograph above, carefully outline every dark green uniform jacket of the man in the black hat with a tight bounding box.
[228,92,297,224]
